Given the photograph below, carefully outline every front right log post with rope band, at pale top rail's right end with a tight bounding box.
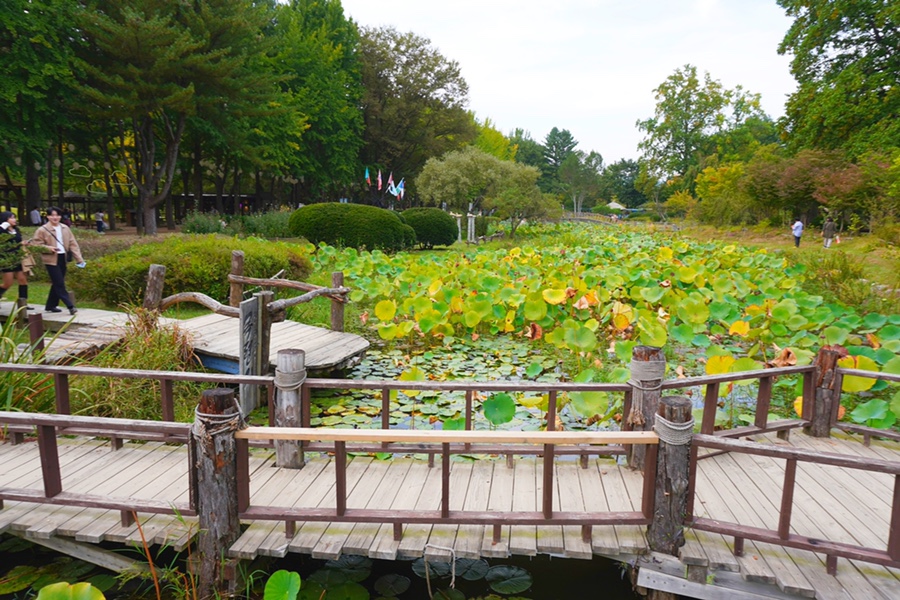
[647,396,694,556]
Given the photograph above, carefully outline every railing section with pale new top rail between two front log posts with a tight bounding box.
[235,427,659,542]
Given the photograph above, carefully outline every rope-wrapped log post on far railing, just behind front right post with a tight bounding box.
[625,346,666,469]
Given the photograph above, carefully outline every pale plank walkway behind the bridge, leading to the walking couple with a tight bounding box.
[0,302,369,373]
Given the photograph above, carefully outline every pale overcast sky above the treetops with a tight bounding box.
[341,0,796,164]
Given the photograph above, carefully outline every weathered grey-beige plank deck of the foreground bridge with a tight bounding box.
[0,431,900,600]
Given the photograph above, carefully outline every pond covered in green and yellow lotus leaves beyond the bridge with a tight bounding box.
[300,224,900,429]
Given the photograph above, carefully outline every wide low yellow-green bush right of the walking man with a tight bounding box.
[71,235,312,306]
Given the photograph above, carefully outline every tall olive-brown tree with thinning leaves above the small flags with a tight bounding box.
[360,27,477,184]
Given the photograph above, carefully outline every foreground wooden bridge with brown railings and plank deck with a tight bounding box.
[0,353,900,599]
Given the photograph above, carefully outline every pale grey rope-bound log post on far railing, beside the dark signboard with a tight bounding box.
[275,349,306,469]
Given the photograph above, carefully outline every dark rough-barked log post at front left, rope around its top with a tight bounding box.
[188,388,243,598]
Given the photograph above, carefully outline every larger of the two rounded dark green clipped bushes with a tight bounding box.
[290,202,416,252]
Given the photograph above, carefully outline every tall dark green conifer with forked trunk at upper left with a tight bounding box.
[77,0,282,235]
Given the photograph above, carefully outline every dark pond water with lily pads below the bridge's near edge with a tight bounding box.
[0,535,639,600]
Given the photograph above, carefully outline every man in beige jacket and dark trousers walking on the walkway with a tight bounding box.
[30,206,87,315]
